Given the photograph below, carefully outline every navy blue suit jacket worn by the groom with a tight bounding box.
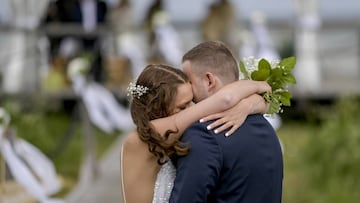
[170,114,283,203]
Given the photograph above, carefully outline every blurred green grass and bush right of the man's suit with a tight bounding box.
[278,98,360,203]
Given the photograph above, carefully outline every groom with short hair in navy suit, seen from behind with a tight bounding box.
[170,41,283,203]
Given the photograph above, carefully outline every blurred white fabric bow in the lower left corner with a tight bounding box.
[0,126,64,203]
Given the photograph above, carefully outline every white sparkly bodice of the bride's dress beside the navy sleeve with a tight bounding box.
[152,159,176,203]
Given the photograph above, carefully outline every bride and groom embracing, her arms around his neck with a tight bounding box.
[120,41,283,203]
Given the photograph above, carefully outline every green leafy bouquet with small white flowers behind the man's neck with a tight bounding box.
[239,56,296,114]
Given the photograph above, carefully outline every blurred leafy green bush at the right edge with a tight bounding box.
[302,98,360,203]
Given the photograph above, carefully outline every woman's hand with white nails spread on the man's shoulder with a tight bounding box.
[200,94,269,136]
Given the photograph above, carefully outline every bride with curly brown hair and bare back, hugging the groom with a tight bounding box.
[120,65,271,203]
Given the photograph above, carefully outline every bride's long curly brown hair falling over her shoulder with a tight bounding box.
[130,64,189,165]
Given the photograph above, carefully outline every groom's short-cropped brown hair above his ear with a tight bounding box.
[182,41,239,83]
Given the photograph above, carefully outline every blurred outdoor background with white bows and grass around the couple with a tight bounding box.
[0,0,360,203]
